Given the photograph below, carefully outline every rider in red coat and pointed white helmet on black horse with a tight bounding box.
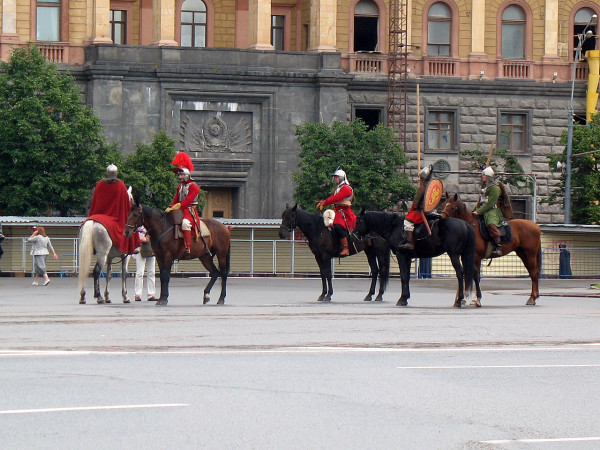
[317,168,356,256]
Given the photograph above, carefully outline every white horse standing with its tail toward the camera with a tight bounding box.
[79,187,131,304]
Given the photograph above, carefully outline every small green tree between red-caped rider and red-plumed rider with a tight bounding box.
[119,131,205,211]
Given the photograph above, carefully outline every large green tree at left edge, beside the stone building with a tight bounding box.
[0,46,110,215]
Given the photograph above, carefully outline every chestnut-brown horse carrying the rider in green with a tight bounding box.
[442,192,542,306]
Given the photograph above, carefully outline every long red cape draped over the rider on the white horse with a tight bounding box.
[86,180,140,253]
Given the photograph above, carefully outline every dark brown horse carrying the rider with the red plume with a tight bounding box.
[125,205,230,305]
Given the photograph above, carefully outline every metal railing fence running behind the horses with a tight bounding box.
[0,237,600,278]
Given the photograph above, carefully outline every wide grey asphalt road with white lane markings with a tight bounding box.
[0,278,600,449]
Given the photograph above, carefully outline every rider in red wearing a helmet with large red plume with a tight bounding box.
[165,152,200,259]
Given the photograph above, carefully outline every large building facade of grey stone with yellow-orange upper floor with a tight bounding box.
[0,0,600,223]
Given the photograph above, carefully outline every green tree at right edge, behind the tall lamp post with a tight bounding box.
[543,114,600,225]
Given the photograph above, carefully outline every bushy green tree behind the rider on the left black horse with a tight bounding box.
[294,120,415,210]
